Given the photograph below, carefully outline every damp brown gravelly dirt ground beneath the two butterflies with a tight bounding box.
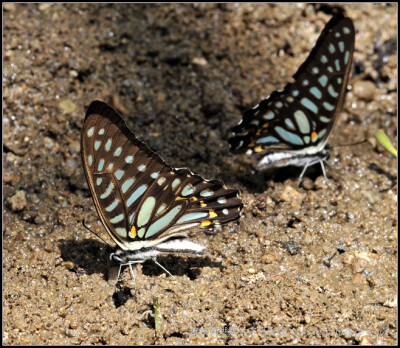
[3,4,397,345]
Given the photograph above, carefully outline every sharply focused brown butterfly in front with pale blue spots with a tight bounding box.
[81,101,243,278]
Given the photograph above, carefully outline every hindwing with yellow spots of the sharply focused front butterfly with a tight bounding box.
[133,169,241,239]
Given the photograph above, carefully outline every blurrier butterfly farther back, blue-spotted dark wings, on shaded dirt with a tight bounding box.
[228,14,355,184]
